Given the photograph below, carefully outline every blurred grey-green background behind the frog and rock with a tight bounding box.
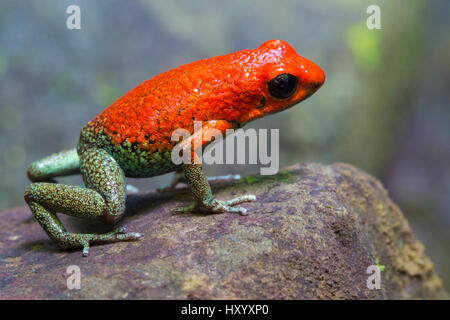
[0,0,450,289]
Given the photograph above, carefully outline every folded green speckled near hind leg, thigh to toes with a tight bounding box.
[25,149,141,256]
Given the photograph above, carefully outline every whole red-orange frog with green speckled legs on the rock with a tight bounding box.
[24,40,325,256]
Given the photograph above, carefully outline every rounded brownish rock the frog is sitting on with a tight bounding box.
[0,163,447,299]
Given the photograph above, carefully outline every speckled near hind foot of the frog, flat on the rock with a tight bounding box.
[57,227,143,257]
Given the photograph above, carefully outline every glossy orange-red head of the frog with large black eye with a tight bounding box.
[241,40,325,122]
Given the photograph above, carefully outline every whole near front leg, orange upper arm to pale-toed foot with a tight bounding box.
[174,120,256,215]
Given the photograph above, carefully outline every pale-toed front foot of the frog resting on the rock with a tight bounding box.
[175,194,256,216]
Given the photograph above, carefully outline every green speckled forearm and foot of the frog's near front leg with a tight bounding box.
[178,164,256,215]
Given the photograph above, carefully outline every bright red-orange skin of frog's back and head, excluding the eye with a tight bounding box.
[88,40,324,151]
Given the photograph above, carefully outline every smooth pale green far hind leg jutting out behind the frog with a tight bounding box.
[27,149,80,182]
